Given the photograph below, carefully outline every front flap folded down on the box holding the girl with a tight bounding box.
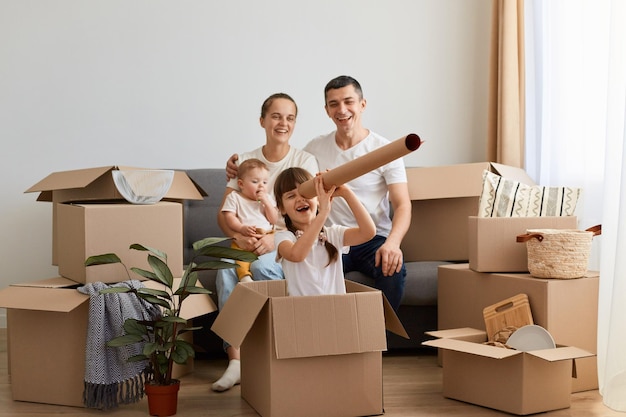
[271,292,387,359]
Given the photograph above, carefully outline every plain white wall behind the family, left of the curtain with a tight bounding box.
[0,0,491,326]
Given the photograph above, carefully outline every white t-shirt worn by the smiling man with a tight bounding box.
[304,131,407,237]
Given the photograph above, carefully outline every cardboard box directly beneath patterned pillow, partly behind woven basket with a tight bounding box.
[468,216,578,272]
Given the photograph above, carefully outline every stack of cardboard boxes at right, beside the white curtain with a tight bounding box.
[403,163,599,414]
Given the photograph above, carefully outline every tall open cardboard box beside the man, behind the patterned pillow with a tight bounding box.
[402,162,535,261]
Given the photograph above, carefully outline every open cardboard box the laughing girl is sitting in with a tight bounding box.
[211,280,408,417]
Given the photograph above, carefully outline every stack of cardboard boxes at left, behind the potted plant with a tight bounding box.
[0,166,216,407]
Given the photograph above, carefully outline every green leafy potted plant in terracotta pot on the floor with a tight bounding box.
[85,238,257,416]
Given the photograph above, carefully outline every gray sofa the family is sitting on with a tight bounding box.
[183,168,443,354]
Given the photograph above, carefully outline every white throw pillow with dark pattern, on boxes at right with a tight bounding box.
[478,170,581,217]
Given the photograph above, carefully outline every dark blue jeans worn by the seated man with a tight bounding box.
[343,235,406,311]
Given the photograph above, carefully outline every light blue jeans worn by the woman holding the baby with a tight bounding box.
[215,251,285,350]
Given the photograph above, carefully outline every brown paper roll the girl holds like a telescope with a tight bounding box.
[298,133,422,198]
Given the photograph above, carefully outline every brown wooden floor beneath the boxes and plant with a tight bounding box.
[0,329,625,417]
